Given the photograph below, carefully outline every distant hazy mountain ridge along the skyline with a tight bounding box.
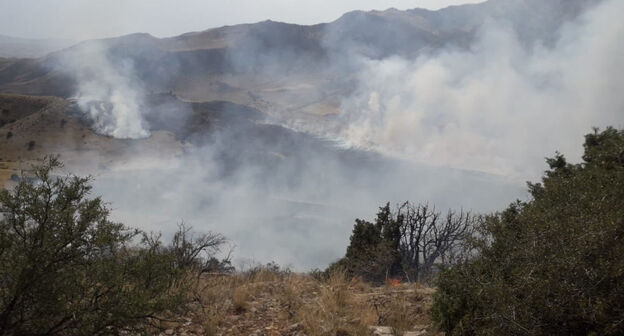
[0,0,599,100]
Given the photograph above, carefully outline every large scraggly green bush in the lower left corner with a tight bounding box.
[0,158,228,335]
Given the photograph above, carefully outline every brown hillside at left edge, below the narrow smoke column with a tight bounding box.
[0,94,182,183]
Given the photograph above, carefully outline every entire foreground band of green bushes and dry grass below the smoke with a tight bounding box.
[0,128,624,335]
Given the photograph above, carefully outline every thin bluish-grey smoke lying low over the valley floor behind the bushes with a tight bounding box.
[90,125,523,270]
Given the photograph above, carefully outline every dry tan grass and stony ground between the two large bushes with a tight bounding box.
[158,270,437,336]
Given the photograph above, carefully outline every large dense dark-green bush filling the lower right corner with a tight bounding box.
[432,128,624,335]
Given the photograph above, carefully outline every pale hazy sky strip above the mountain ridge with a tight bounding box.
[0,0,483,39]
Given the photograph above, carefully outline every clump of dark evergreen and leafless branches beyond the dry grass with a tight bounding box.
[332,202,477,282]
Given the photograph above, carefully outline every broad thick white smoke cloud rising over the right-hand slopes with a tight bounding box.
[312,0,624,180]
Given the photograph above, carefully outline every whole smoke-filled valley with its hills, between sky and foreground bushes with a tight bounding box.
[0,0,624,270]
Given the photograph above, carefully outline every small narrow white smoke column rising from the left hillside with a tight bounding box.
[56,40,150,139]
